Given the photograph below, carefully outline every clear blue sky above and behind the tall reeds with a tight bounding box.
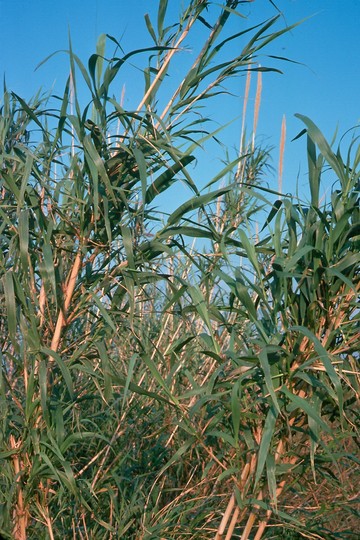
[0,0,360,204]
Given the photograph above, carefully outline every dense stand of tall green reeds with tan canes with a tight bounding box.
[0,0,360,540]
